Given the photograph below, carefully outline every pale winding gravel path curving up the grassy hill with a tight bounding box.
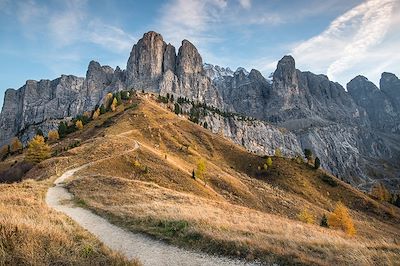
[46,143,258,266]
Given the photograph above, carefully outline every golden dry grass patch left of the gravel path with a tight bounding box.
[0,180,138,265]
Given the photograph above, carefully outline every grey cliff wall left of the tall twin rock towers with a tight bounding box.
[0,61,123,145]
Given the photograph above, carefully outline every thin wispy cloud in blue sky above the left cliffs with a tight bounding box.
[14,0,134,53]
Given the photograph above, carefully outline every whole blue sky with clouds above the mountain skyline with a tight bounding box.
[0,0,400,106]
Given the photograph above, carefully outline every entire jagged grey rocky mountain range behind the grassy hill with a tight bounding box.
[0,32,400,188]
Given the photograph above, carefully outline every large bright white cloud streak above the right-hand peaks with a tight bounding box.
[292,0,400,83]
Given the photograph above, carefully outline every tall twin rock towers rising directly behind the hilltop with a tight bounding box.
[126,31,222,107]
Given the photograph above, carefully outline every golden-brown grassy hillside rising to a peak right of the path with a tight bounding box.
[3,93,400,265]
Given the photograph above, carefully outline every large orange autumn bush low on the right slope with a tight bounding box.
[328,202,356,236]
